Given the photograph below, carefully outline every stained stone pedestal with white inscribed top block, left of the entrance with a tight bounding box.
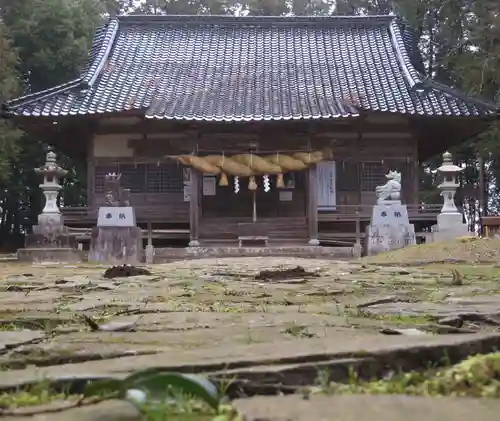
[89,206,142,265]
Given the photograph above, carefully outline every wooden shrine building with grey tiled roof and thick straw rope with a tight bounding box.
[4,15,499,245]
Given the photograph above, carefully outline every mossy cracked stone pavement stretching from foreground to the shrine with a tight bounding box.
[0,257,500,421]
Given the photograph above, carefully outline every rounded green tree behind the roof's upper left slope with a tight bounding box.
[0,0,106,92]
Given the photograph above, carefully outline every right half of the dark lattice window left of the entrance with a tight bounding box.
[146,162,184,193]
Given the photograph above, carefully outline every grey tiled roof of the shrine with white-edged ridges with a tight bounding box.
[7,15,496,121]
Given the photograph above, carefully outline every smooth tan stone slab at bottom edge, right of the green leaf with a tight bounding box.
[234,395,500,421]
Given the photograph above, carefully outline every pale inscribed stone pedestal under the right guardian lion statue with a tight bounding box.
[365,200,416,256]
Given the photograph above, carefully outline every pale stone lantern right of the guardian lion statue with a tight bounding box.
[432,152,471,241]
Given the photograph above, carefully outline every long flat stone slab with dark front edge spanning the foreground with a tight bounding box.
[0,332,500,389]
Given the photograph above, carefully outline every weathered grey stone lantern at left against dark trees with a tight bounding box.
[35,151,68,225]
